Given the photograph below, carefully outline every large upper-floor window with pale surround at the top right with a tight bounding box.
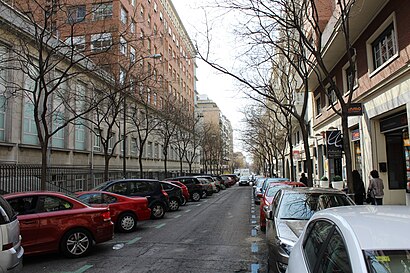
[372,23,397,70]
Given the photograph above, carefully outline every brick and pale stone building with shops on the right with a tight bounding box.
[310,0,410,204]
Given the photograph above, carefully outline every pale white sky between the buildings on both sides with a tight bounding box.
[172,0,249,152]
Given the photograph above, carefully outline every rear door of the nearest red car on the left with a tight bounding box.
[37,195,74,252]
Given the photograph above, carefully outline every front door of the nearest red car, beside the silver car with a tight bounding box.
[7,196,40,252]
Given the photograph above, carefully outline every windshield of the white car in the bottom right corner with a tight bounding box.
[364,250,410,273]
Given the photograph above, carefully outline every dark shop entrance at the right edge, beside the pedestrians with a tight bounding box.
[379,112,410,190]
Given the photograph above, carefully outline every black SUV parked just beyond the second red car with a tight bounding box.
[93,179,169,219]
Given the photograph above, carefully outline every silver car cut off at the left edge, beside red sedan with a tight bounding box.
[0,196,24,273]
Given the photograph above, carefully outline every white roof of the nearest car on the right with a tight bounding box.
[311,205,410,250]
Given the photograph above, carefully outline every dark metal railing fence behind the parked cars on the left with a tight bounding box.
[0,164,174,194]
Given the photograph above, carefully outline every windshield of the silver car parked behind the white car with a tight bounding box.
[278,192,353,220]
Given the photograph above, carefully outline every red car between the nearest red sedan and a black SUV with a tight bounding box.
[76,191,151,232]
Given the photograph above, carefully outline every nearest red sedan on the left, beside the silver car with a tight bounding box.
[3,192,114,257]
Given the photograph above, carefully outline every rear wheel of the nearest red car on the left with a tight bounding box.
[60,228,93,258]
